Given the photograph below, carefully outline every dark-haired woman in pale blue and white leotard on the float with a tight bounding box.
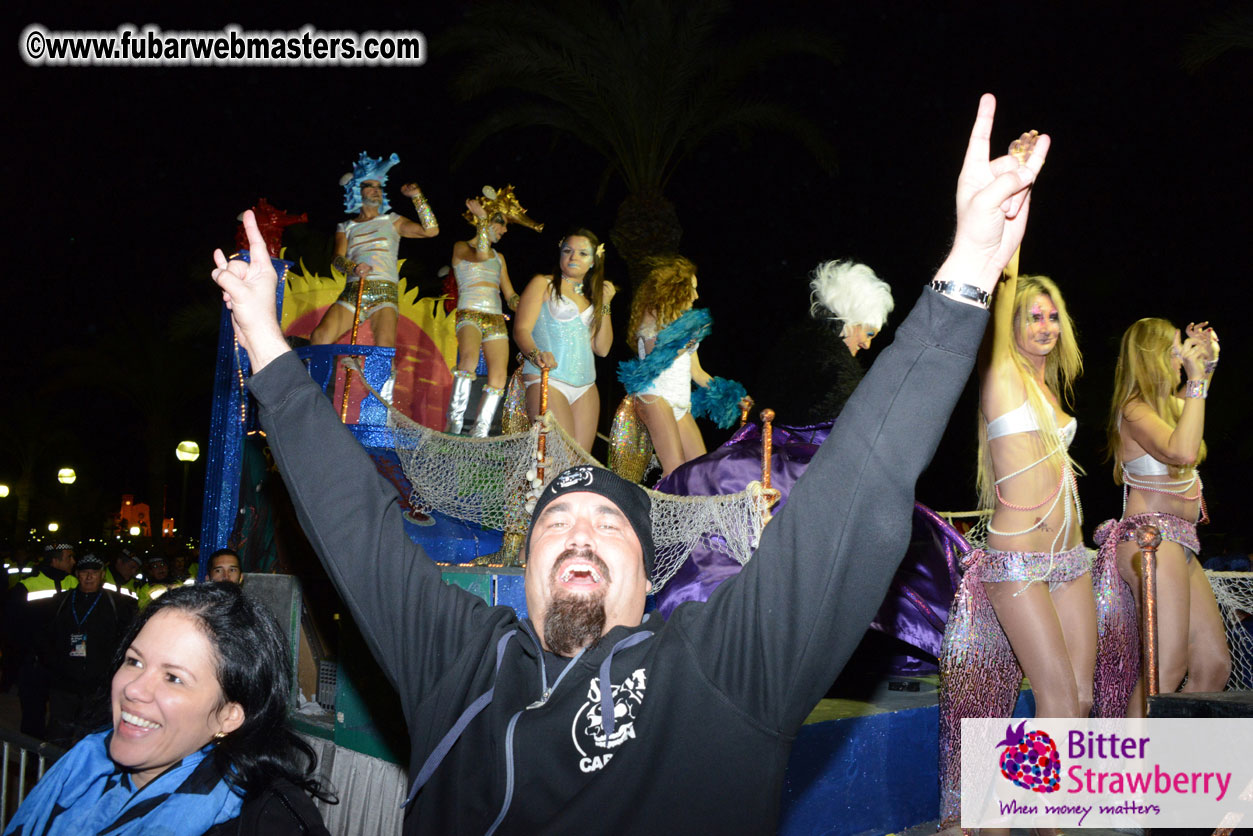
[514,229,616,450]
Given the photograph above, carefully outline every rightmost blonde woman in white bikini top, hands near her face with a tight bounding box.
[1098,318,1232,717]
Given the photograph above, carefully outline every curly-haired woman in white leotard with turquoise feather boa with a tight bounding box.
[627,256,712,476]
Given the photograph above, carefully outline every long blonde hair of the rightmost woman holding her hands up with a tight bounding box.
[1105,317,1205,485]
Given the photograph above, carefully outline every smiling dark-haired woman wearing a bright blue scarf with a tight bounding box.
[6,583,332,836]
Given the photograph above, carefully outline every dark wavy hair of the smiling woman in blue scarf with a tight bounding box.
[114,583,336,803]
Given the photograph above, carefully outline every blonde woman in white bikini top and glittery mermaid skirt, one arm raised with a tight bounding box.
[940,273,1096,825]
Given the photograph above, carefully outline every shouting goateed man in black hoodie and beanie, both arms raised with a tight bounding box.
[213,95,1049,833]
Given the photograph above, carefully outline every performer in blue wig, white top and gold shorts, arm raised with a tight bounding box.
[309,152,440,402]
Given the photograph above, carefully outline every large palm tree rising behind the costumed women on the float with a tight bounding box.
[436,0,840,284]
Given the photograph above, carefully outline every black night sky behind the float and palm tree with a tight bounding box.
[0,1,1253,546]
